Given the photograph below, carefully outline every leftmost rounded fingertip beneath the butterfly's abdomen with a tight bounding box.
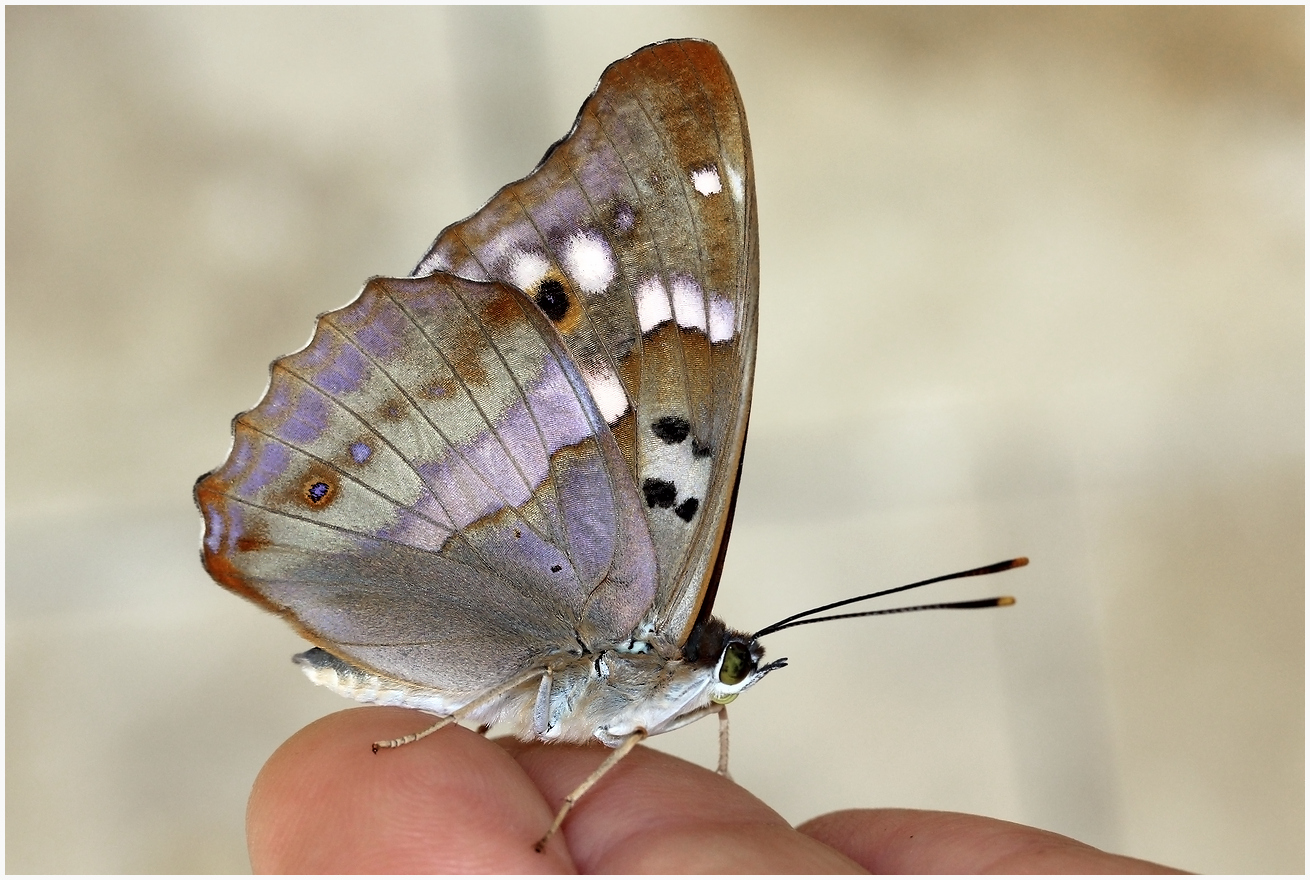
[246,707,574,873]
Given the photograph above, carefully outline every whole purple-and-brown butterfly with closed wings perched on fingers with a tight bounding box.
[195,39,1021,849]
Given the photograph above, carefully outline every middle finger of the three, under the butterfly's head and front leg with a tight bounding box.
[504,741,861,873]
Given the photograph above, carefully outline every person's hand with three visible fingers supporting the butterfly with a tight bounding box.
[246,707,1189,873]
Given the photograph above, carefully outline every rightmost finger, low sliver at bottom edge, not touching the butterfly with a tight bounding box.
[798,809,1183,873]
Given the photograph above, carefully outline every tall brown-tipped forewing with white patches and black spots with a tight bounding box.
[415,41,758,643]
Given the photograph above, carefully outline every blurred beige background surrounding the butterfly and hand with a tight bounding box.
[5,8,1305,872]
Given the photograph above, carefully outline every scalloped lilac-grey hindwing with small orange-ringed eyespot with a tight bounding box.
[197,274,656,697]
